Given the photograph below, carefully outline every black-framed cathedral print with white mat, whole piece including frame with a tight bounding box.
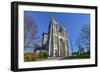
[11,2,97,71]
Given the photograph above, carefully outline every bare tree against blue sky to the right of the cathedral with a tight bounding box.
[77,25,90,53]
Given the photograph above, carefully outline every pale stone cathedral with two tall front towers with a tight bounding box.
[42,17,69,57]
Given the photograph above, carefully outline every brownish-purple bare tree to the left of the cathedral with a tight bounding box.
[24,16,38,48]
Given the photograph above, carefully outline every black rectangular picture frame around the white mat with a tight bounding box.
[11,2,97,71]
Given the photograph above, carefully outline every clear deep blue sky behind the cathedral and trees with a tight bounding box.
[24,11,90,51]
